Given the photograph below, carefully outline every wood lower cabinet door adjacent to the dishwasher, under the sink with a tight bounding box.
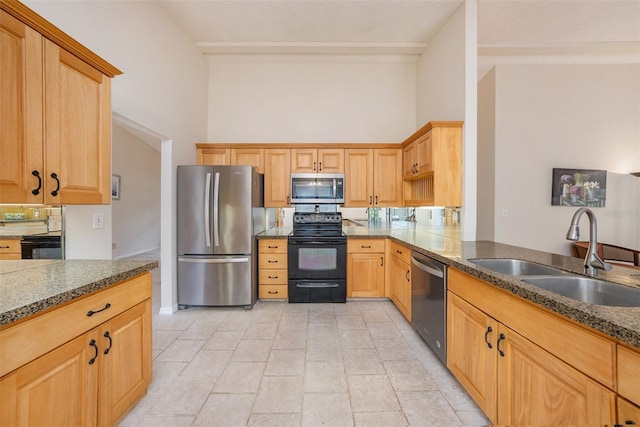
[447,292,498,423]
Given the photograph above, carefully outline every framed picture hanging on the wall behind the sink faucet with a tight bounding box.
[551,168,607,208]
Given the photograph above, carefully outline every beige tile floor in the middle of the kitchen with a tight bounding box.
[120,253,489,427]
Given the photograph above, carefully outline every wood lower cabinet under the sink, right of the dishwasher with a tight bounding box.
[447,268,616,425]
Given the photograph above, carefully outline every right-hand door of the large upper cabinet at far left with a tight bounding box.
[44,40,111,205]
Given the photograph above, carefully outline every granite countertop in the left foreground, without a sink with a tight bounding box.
[0,260,158,327]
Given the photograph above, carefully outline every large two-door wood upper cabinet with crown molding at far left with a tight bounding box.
[0,0,121,205]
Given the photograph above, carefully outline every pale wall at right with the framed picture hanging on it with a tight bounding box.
[479,64,640,254]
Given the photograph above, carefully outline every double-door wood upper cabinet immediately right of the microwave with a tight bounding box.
[344,148,402,207]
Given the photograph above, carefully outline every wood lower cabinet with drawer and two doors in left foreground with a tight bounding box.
[0,273,151,426]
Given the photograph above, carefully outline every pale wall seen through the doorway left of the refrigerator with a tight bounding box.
[111,124,161,258]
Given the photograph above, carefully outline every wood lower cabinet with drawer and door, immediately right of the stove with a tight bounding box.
[347,239,385,298]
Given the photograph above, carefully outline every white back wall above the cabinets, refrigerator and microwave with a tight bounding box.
[208,54,415,142]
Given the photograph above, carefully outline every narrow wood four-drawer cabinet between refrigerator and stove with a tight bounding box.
[258,239,289,299]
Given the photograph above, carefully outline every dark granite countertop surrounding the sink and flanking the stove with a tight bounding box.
[259,222,640,348]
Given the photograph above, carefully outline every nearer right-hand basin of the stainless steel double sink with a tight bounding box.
[522,276,640,307]
